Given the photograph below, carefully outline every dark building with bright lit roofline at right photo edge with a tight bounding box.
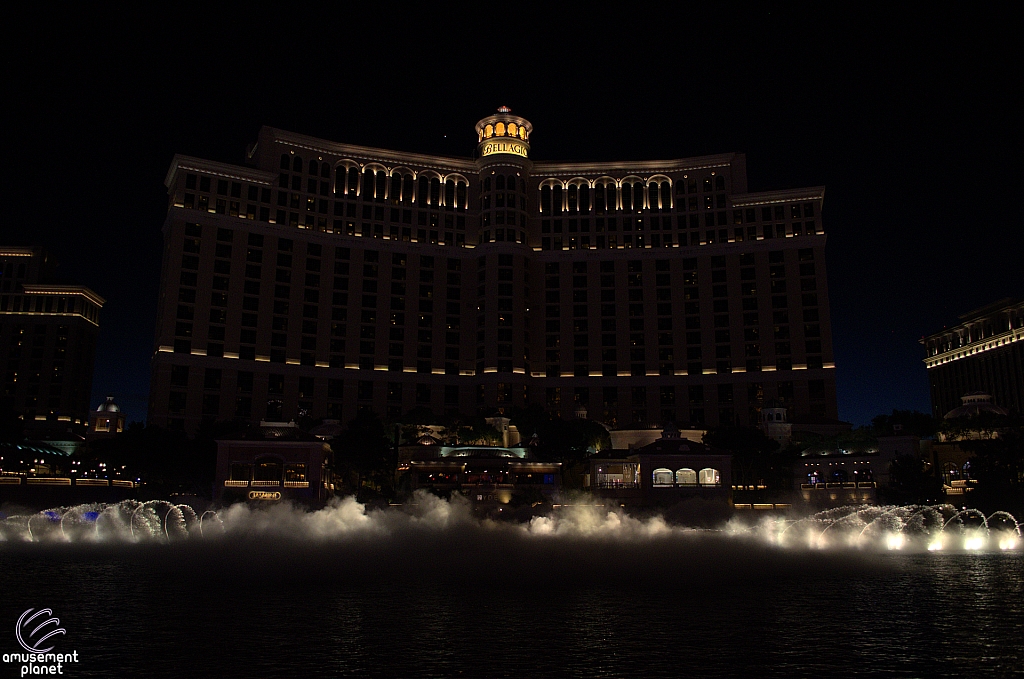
[921,297,1024,418]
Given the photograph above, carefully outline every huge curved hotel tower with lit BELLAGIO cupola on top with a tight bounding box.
[150,108,837,430]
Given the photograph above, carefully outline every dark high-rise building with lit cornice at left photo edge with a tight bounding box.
[0,247,104,429]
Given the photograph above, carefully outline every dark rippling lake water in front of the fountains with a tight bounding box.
[0,499,1024,678]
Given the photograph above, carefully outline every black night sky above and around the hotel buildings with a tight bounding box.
[6,3,1024,425]
